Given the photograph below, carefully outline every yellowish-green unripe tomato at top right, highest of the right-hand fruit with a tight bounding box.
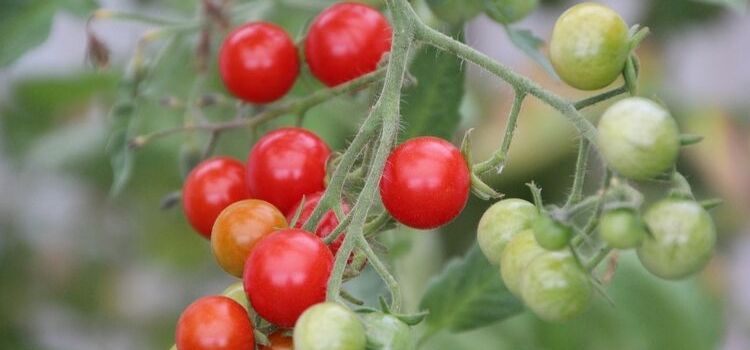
[549,2,630,90]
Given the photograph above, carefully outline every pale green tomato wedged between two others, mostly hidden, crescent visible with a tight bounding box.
[500,230,546,297]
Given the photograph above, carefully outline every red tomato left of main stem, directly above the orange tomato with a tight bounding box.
[247,128,331,213]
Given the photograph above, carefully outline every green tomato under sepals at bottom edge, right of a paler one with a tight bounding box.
[362,312,417,350]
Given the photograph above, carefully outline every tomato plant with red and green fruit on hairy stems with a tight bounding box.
[92,0,728,350]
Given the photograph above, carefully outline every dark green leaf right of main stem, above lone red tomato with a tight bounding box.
[401,31,465,139]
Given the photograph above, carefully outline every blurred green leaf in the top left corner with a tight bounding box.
[0,0,96,67]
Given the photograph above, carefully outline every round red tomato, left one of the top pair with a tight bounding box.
[219,22,299,103]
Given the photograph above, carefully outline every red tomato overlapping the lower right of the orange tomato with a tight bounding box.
[243,229,333,328]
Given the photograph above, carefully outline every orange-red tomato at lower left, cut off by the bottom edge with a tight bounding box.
[175,296,255,350]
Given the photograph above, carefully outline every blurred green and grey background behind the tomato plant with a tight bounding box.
[0,0,750,350]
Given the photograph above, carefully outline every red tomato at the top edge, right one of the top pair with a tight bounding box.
[305,2,391,86]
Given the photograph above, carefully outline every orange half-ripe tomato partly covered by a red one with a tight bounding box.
[211,199,287,277]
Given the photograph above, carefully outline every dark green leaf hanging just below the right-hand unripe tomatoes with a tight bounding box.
[420,245,523,332]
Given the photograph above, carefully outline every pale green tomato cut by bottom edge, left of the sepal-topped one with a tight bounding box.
[294,302,366,350]
